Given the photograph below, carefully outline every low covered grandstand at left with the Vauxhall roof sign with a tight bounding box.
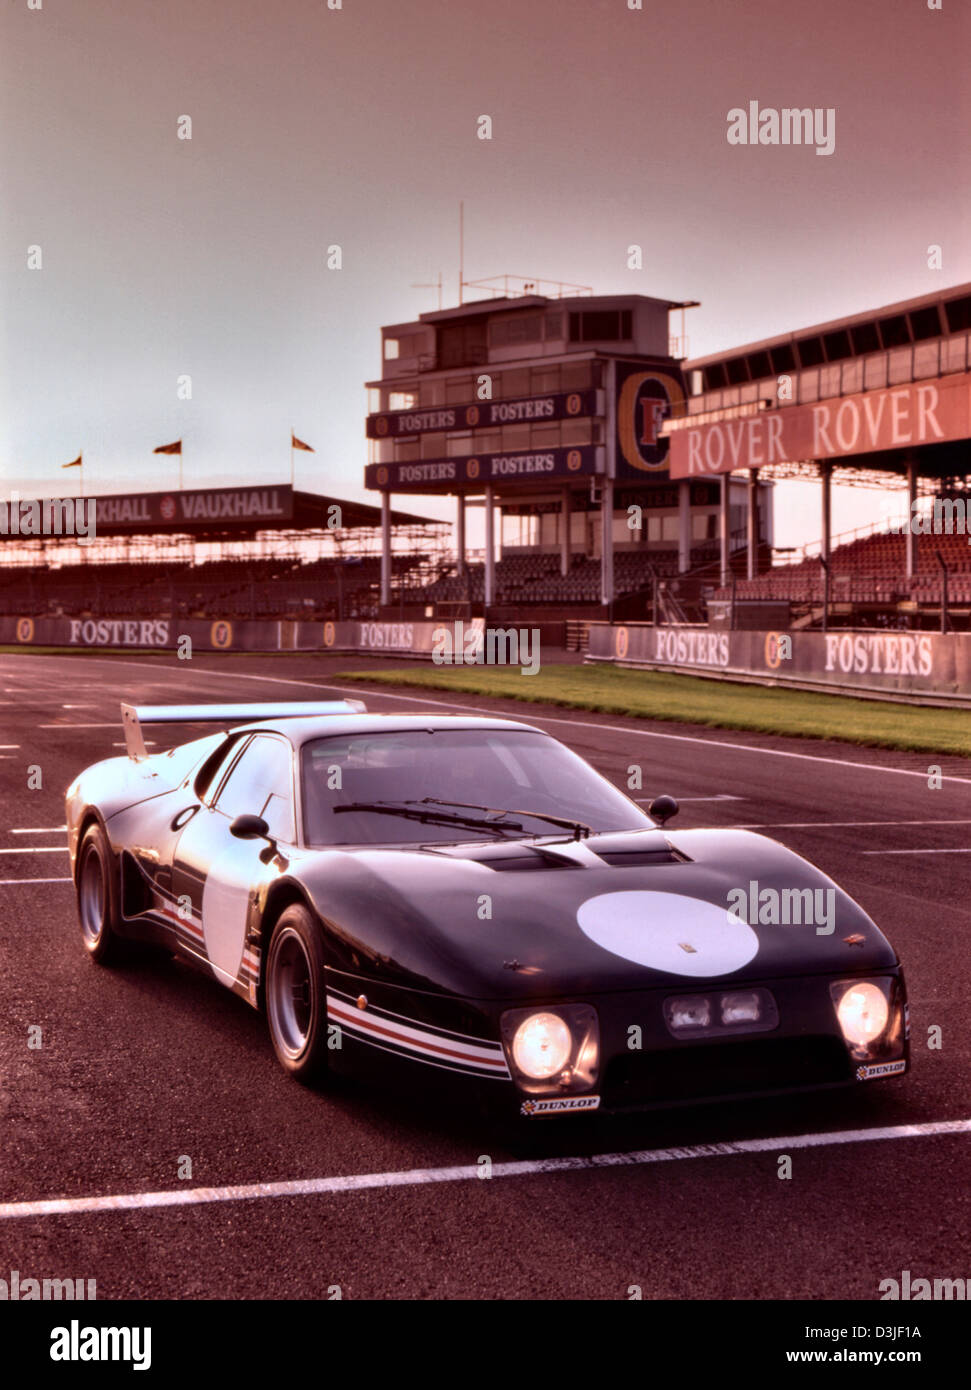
[0,488,449,620]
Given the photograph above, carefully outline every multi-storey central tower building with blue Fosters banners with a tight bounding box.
[365,293,771,605]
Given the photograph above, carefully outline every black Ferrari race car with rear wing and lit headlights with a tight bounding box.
[67,701,908,1116]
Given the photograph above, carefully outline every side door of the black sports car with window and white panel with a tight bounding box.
[172,734,294,986]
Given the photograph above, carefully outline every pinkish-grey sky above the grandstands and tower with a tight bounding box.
[0,0,971,543]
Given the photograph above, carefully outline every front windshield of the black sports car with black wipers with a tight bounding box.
[301,728,653,845]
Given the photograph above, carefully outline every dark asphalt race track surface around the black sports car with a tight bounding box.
[0,655,971,1300]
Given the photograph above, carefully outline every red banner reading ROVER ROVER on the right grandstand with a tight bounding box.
[670,373,971,478]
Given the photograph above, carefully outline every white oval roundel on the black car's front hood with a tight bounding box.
[576,891,758,977]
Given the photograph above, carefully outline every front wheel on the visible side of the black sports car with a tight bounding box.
[265,904,328,1083]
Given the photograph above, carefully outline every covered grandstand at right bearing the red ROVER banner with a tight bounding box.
[665,285,971,631]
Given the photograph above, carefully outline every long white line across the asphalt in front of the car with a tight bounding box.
[0,1120,971,1220]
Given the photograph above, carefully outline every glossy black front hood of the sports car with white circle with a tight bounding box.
[292,830,897,999]
